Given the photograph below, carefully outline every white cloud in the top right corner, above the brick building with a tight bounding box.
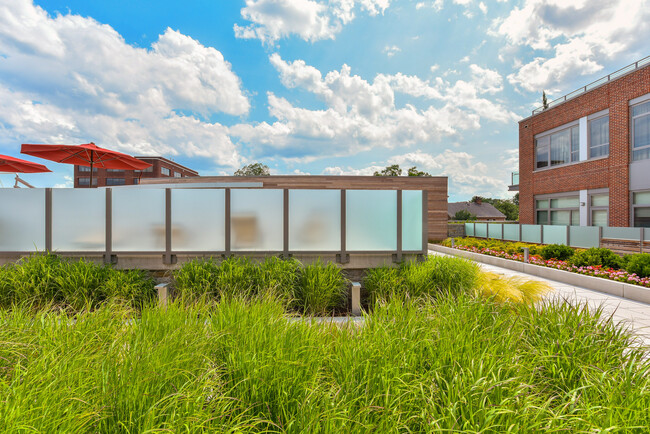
[491,0,650,91]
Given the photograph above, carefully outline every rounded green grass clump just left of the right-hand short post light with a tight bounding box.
[294,260,348,314]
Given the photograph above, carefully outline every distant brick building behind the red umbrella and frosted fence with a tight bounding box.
[74,157,199,188]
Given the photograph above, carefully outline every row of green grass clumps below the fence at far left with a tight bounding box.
[0,254,156,310]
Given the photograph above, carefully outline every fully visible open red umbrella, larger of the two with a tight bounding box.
[20,142,151,187]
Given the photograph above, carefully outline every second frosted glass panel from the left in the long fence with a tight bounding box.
[52,188,106,252]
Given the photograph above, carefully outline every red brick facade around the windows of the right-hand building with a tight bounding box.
[519,66,650,226]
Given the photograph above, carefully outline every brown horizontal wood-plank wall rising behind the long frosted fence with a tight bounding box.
[141,175,447,240]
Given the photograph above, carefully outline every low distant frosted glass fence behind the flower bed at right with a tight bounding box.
[465,223,650,249]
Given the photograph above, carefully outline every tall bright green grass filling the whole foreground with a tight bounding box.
[0,292,650,433]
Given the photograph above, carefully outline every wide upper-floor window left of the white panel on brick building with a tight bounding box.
[535,125,580,169]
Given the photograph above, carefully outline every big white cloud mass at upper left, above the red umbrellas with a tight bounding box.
[0,0,250,166]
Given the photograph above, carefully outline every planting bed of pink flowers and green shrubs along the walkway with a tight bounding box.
[442,237,650,287]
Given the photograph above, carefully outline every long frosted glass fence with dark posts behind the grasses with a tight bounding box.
[0,188,427,264]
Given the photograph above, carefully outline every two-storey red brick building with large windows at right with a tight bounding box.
[519,57,650,227]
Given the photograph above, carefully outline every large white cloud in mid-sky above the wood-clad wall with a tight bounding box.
[229,53,517,156]
